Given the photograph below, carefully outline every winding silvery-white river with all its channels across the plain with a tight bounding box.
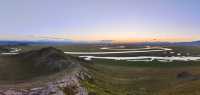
[1,47,200,62]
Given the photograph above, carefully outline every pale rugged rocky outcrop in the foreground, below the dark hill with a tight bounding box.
[0,67,91,95]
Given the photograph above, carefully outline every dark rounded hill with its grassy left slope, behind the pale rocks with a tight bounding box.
[0,48,82,83]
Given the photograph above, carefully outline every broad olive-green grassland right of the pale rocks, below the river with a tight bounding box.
[83,60,200,95]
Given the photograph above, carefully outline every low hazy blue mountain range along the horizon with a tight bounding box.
[0,40,200,46]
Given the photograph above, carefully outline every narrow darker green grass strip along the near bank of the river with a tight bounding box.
[92,59,200,68]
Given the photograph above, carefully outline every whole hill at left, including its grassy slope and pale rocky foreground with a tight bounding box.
[0,47,90,95]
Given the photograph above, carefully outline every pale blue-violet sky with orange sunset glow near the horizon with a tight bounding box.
[0,0,200,42]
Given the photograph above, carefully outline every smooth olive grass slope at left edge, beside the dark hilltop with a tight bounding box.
[0,57,51,83]
